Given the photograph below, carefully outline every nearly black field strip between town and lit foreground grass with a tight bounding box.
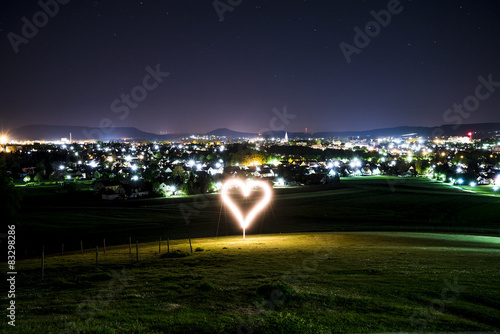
[14,177,500,256]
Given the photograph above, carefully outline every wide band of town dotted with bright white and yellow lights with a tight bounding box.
[0,133,500,199]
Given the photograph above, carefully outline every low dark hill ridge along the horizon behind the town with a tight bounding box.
[9,123,500,141]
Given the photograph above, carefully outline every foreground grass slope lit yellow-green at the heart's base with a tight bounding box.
[6,232,500,333]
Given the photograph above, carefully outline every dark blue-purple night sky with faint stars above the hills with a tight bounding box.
[0,0,500,133]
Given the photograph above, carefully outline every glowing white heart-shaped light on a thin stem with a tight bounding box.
[221,179,272,239]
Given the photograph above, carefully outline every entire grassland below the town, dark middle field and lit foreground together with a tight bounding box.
[6,177,500,333]
